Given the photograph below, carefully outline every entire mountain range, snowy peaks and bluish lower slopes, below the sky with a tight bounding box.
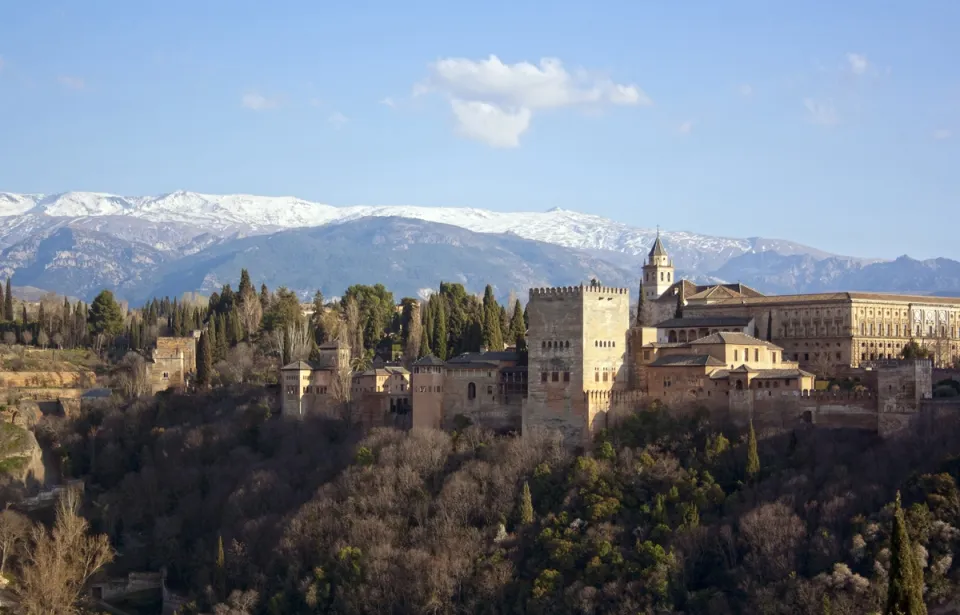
[0,191,960,304]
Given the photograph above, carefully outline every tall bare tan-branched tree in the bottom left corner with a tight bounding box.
[19,489,114,615]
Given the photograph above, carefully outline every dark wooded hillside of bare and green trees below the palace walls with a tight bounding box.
[18,387,960,615]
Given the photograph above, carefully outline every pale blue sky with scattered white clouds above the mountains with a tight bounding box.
[0,0,960,259]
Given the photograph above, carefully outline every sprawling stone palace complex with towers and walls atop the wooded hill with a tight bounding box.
[282,236,944,445]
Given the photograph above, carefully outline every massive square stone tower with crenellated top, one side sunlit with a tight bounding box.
[522,284,630,446]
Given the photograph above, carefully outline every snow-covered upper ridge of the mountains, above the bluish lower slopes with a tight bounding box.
[0,191,848,273]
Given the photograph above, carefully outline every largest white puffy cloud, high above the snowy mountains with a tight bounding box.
[413,55,653,147]
